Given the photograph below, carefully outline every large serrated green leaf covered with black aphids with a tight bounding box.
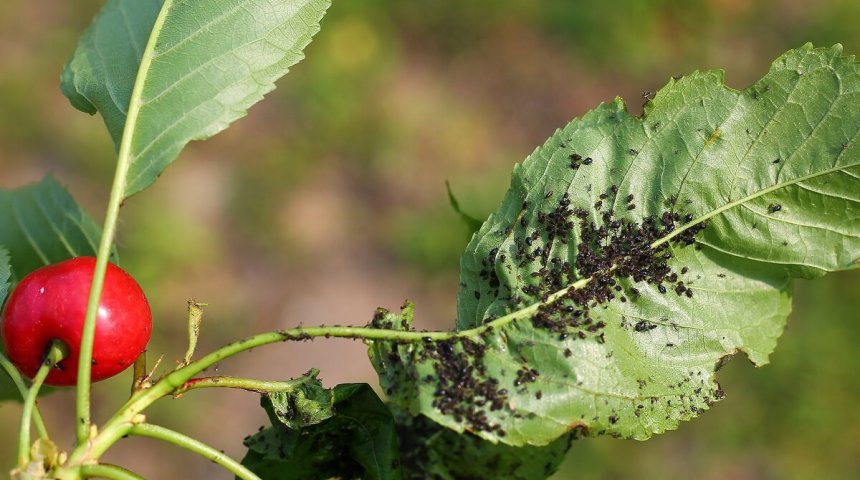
[371,45,860,445]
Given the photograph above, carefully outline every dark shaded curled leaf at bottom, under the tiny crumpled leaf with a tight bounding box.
[242,384,401,480]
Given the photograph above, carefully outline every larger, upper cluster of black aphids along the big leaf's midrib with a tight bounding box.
[484,165,706,341]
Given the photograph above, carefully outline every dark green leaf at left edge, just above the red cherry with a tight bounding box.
[0,176,109,279]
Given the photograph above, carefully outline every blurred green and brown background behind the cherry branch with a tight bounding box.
[0,0,860,479]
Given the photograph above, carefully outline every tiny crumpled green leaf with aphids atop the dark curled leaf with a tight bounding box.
[268,373,333,429]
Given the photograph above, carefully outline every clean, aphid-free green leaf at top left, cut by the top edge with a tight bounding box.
[62,0,330,197]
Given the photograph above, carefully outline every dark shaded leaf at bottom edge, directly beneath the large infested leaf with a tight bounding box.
[397,416,572,480]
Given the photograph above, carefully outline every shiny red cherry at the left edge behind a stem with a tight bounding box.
[2,257,152,386]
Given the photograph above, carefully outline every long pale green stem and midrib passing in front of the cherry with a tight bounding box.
[75,0,173,445]
